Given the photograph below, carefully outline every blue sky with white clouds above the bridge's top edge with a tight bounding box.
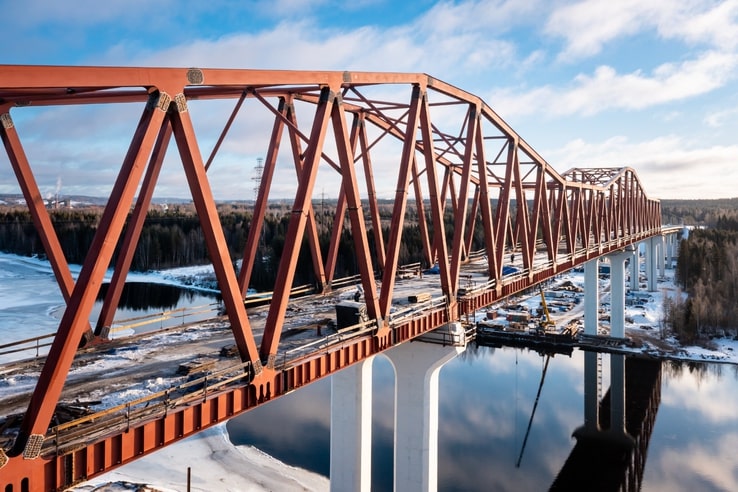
[0,0,738,198]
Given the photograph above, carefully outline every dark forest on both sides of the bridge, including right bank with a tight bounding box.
[0,198,738,341]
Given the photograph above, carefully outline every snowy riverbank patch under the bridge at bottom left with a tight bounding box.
[70,424,329,492]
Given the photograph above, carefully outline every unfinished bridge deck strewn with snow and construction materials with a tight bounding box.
[0,237,660,454]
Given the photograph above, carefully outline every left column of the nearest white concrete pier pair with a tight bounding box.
[330,357,374,492]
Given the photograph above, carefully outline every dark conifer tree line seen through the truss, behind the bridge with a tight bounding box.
[0,204,440,291]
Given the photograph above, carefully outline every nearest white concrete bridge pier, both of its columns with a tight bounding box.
[330,327,466,492]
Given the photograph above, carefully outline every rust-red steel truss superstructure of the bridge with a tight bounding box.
[0,66,661,490]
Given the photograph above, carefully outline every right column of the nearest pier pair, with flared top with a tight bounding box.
[386,342,465,492]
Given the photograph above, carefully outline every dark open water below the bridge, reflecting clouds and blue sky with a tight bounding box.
[228,347,738,491]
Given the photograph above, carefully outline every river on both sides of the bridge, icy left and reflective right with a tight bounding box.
[0,256,738,491]
